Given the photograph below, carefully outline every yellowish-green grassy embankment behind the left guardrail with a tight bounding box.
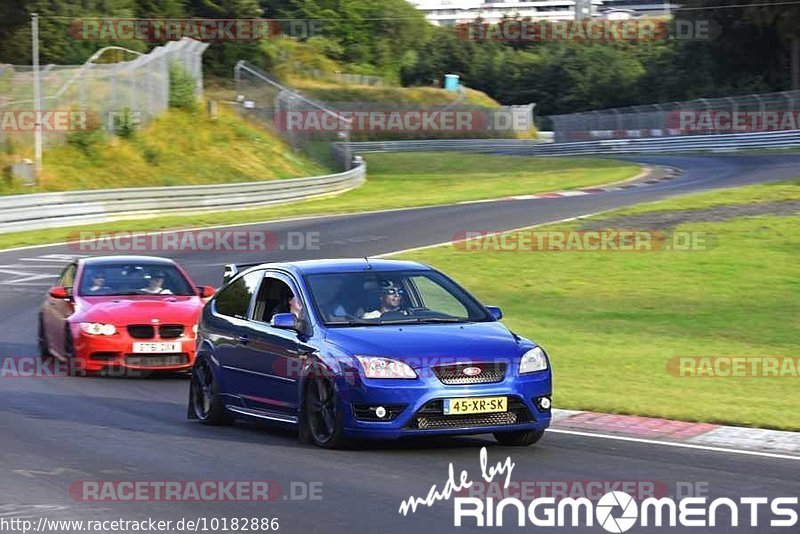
[0,105,329,194]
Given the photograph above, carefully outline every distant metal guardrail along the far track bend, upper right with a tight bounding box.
[350,130,800,156]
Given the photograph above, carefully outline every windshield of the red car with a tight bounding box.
[79,262,196,297]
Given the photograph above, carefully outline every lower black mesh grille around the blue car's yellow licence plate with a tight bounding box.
[407,396,535,430]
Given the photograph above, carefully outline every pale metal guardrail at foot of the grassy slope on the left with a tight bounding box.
[0,162,367,233]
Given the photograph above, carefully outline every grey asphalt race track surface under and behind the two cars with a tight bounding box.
[0,155,800,533]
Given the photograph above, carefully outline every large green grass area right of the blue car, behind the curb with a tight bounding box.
[394,179,800,430]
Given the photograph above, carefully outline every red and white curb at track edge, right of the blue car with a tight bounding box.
[552,409,800,460]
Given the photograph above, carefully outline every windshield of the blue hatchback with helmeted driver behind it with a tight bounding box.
[306,271,492,326]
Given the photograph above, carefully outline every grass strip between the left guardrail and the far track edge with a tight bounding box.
[0,152,639,248]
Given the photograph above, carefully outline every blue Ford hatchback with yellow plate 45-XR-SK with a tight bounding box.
[188,259,552,448]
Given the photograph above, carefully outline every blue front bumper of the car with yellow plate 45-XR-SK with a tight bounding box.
[338,371,552,439]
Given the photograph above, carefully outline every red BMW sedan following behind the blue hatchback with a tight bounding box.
[39,256,214,374]
